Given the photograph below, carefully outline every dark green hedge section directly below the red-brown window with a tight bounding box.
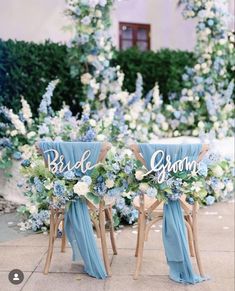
[115,48,195,101]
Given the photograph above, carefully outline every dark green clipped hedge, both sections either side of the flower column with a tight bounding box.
[0,40,194,114]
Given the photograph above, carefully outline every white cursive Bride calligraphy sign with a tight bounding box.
[44,149,99,174]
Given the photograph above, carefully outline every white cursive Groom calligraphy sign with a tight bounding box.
[144,150,198,183]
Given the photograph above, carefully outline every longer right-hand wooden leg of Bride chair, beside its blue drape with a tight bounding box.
[99,201,112,276]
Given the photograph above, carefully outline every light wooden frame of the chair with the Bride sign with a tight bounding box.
[36,143,117,276]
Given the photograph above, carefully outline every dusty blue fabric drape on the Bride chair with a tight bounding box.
[39,142,107,279]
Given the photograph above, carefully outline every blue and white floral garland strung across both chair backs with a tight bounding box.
[19,141,233,231]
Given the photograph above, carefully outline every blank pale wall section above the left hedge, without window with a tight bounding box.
[0,0,71,42]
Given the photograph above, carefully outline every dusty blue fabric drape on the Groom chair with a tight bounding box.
[139,143,206,284]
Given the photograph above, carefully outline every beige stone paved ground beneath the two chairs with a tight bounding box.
[0,201,234,291]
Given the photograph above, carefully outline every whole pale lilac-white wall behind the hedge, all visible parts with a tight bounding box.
[0,0,234,50]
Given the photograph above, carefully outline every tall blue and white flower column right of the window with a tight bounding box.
[166,0,235,138]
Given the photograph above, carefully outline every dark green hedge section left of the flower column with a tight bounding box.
[0,40,82,114]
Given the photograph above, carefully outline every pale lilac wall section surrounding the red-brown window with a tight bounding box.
[112,0,195,50]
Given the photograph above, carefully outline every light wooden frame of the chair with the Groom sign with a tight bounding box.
[130,144,209,279]
